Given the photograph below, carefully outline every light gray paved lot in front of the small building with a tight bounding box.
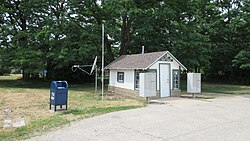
[30,95,250,141]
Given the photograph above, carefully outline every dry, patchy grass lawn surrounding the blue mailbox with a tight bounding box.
[0,75,145,141]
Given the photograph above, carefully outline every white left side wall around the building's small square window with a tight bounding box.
[109,70,135,90]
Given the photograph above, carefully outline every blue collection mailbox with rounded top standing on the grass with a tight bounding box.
[49,81,68,111]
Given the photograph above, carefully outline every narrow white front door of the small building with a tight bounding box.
[159,64,171,97]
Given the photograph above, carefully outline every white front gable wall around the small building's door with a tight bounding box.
[149,61,179,90]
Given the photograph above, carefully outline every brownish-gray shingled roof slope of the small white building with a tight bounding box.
[105,51,168,69]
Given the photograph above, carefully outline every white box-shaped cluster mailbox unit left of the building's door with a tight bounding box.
[139,72,156,97]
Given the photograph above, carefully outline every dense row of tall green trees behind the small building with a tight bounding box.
[0,0,250,81]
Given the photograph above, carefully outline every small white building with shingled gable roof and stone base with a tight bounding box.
[105,51,187,98]
